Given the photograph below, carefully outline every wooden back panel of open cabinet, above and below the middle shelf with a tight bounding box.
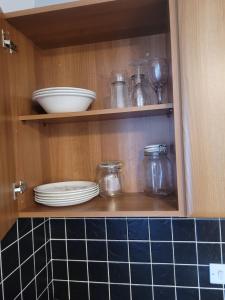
[32,34,178,199]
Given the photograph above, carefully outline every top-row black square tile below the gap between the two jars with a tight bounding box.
[127,218,149,240]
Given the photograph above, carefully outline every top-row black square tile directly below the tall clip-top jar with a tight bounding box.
[150,219,172,241]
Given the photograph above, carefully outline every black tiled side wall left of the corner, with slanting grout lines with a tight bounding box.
[0,218,53,300]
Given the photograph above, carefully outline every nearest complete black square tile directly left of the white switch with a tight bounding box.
[175,265,198,287]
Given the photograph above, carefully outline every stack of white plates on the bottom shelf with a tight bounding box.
[34,181,99,206]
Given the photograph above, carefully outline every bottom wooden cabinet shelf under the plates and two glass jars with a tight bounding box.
[19,193,179,218]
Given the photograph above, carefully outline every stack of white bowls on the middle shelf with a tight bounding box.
[32,87,96,113]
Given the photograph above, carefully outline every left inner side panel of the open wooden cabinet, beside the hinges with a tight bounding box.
[2,23,44,209]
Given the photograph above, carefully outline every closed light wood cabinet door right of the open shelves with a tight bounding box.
[178,0,225,217]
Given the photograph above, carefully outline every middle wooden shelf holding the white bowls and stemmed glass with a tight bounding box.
[19,103,173,123]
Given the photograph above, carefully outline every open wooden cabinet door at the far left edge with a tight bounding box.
[0,11,17,239]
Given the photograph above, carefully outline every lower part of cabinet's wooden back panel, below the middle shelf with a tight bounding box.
[41,116,174,192]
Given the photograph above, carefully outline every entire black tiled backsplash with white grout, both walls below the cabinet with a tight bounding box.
[0,218,225,300]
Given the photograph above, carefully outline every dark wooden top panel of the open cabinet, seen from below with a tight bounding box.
[5,0,169,49]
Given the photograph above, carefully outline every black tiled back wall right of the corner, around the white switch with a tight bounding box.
[50,218,225,300]
